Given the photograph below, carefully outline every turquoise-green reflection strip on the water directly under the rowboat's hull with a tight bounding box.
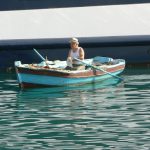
[18,78,121,102]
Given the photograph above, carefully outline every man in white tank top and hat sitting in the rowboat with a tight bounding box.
[66,38,85,70]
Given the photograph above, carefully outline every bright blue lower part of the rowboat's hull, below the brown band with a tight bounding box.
[17,70,122,88]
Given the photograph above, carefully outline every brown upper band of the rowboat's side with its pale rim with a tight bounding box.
[16,62,125,78]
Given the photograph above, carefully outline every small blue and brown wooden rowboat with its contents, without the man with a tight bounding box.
[15,56,125,88]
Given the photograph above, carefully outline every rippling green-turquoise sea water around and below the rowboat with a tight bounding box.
[0,68,150,150]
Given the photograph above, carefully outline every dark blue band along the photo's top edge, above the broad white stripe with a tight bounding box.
[0,0,150,11]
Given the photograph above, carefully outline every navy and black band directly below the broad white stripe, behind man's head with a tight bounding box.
[0,35,150,50]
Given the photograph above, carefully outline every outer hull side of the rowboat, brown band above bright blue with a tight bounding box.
[16,62,125,88]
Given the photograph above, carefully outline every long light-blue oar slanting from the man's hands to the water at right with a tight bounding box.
[74,58,123,80]
